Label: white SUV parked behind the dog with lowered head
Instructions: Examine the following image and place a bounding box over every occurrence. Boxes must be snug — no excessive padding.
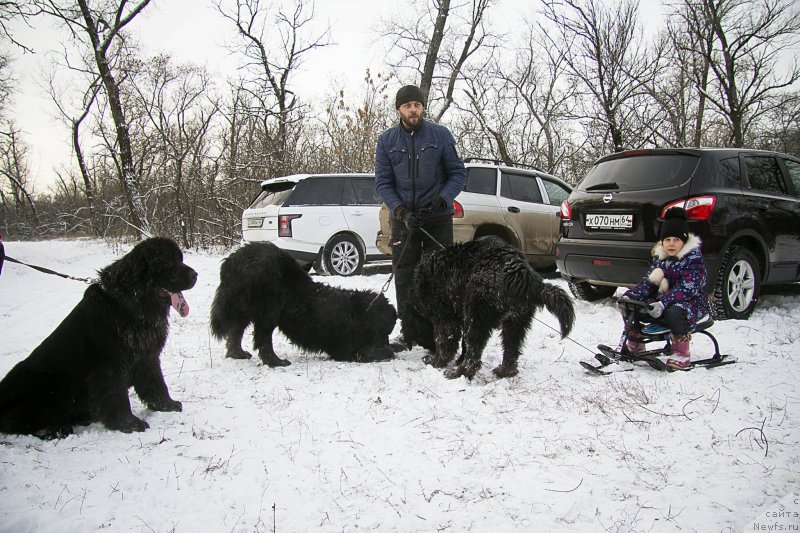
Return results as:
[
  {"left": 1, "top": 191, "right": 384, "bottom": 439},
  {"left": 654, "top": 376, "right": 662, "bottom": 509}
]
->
[{"left": 242, "top": 174, "right": 389, "bottom": 276}]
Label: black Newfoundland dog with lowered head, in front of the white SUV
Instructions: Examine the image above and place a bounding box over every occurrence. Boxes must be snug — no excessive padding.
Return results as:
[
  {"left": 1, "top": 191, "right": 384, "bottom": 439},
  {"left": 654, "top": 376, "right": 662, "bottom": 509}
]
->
[{"left": 211, "top": 242, "right": 397, "bottom": 367}]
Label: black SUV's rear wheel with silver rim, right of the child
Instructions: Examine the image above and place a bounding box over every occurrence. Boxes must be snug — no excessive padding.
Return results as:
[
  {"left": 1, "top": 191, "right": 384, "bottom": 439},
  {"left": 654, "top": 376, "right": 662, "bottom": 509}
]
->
[{"left": 711, "top": 246, "right": 761, "bottom": 320}]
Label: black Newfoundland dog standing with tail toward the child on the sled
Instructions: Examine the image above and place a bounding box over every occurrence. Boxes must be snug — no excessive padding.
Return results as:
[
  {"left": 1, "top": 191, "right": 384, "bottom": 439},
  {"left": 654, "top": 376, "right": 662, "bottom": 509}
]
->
[{"left": 414, "top": 238, "right": 575, "bottom": 379}]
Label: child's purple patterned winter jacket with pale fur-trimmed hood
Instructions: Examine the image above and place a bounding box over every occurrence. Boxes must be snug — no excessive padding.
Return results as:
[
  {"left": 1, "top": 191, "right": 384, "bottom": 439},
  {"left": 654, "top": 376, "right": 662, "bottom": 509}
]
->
[{"left": 623, "top": 233, "right": 710, "bottom": 329}]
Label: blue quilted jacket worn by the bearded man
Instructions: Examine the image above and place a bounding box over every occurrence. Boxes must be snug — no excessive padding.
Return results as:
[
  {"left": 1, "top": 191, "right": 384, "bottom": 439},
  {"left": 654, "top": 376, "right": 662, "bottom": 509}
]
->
[{"left": 375, "top": 120, "right": 467, "bottom": 217}]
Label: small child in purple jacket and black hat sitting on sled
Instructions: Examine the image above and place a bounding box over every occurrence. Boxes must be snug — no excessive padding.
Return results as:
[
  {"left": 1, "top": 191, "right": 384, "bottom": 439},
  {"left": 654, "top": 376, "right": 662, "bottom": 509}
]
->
[{"left": 623, "top": 207, "right": 709, "bottom": 370}]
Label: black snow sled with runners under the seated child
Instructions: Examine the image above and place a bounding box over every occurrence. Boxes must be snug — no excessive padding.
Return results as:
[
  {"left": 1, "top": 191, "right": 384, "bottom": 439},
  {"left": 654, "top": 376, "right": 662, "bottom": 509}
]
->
[{"left": 580, "top": 298, "right": 736, "bottom": 375}]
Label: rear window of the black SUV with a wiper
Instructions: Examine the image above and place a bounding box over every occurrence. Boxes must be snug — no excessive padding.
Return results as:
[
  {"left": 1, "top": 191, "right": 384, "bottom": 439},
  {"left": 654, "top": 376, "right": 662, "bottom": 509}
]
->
[{"left": 578, "top": 154, "right": 700, "bottom": 191}]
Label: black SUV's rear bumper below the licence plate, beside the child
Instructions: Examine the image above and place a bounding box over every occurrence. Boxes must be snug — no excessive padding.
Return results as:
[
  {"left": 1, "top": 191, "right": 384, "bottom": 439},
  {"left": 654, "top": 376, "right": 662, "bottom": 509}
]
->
[{"left": 556, "top": 238, "right": 653, "bottom": 286}]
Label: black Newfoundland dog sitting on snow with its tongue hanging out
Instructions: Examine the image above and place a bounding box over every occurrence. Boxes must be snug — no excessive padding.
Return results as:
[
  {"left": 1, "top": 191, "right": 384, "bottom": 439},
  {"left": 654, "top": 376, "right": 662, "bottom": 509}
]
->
[{"left": 0, "top": 237, "right": 197, "bottom": 438}]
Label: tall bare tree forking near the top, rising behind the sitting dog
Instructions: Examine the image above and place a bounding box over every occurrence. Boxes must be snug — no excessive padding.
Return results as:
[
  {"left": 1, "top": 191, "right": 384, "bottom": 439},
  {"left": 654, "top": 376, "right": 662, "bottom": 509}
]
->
[{"left": 34, "top": 0, "right": 151, "bottom": 237}]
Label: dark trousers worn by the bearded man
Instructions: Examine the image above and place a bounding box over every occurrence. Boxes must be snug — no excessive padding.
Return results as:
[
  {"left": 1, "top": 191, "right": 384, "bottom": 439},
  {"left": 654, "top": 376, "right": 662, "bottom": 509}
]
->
[{"left": 391, "top": 217, "right": 453, "bottom": 340}]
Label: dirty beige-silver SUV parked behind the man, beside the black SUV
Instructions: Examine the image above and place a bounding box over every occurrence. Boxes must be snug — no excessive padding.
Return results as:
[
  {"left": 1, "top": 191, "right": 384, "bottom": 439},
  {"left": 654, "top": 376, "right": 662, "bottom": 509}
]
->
[{"left": 375, "top": 158, "right": 572, "bottom": 270}]
